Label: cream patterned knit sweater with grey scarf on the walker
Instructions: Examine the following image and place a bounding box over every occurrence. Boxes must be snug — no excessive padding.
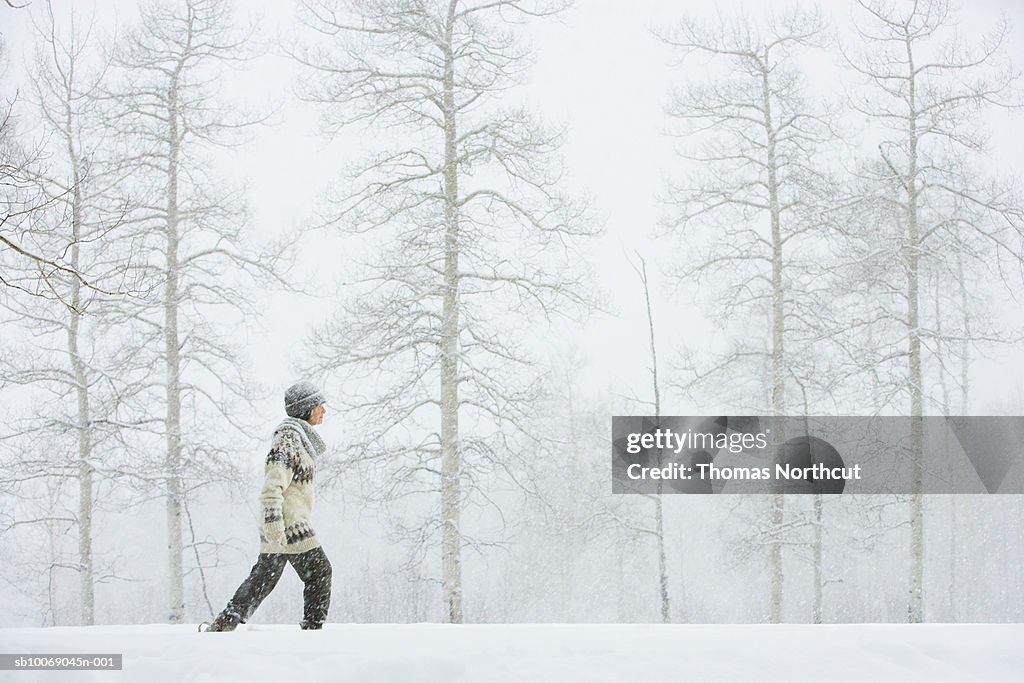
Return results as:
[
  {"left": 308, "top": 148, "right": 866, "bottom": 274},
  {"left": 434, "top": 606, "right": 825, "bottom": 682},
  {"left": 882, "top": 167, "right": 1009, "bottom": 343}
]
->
[{"left": 259, "top": 418, "right": 327, "bottom": 554}]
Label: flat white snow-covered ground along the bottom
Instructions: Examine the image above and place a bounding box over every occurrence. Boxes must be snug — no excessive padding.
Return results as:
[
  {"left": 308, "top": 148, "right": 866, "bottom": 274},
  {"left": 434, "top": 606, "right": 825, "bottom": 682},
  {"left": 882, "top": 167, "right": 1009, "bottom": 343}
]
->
[{"left": 0, "top": 624, "right": 1024, "bottom": 683}]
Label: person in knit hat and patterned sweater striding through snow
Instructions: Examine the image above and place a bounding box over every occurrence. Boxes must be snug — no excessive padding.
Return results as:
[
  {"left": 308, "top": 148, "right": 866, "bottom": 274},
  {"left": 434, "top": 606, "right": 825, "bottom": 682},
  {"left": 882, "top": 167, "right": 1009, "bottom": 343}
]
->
[{"left": 201, "top": 382, "right": 331, "bottom": 631}]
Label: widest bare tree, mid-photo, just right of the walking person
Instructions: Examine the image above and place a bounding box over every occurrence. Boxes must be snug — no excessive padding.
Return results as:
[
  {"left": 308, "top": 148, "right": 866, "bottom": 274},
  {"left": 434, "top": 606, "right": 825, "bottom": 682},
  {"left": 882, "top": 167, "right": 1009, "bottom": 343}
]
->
[{"left": 292, "top": 0, "right": 596, "bottom": 623}]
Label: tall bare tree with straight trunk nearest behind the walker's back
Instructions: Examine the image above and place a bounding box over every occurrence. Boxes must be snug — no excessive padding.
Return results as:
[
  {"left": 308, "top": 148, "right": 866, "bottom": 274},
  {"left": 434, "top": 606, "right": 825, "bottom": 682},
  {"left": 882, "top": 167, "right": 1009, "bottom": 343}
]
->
[{"left": 106, "top": 0, "right": 287, "bottom": 624}]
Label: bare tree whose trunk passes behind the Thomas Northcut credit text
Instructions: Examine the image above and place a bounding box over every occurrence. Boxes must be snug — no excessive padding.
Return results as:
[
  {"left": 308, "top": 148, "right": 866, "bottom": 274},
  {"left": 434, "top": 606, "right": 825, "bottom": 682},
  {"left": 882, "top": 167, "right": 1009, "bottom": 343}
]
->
[{"left": 662, "top": 3, "right": 836, "bottom": 623}]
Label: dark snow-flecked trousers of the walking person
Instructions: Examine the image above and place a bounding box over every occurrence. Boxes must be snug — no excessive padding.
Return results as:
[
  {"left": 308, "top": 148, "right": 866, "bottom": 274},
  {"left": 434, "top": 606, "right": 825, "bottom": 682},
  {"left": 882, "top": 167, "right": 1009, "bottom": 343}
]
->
[{"left": 224, "top": 548, "right": 331, "bottom": 625}]
